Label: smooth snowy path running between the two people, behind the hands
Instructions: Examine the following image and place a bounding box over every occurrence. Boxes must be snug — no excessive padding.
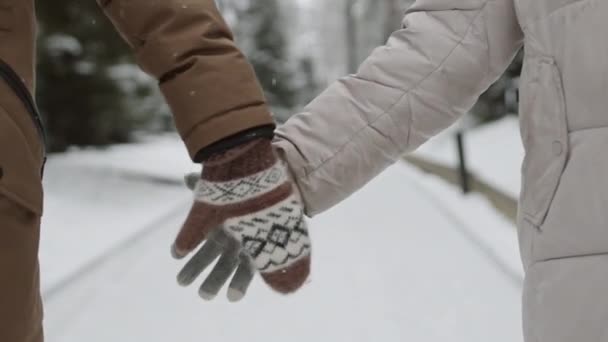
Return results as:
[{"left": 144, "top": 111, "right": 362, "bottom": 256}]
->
[{"left": 41, "top": 165, "right": 522, "bottom": 342}]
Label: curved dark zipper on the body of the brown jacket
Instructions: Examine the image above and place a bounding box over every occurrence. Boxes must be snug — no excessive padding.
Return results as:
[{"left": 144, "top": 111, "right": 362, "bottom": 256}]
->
[{"left": 0, "top": 59, "right": 47, "bottom": 177}]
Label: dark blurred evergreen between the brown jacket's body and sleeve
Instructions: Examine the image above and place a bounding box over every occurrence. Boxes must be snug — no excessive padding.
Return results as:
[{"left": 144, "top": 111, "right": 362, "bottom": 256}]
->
[{"left": 37, "top": 0, "right": 153, "bottom": 151}]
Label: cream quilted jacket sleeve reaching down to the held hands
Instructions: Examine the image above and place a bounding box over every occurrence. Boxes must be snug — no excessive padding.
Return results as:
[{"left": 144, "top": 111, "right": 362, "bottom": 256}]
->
[{"left": 275, "top": 0, "right": 523, "bottom": 216}]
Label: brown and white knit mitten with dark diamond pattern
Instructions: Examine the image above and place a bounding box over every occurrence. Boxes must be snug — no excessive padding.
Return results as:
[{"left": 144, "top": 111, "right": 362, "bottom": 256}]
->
[{"left": 173, "top": 139, "right": 311, "bottom": 293}]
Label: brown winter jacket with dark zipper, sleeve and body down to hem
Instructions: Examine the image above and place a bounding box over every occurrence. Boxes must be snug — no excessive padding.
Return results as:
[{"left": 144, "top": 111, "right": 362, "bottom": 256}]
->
[{"left": 0, "top": 0, "right": 273, "bottom": 214}]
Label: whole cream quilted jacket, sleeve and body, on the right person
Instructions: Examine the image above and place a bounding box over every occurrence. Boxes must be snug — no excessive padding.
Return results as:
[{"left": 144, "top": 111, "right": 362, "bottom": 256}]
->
[{"left": 275, "top": 0, "right": 608, "bottom": 342}]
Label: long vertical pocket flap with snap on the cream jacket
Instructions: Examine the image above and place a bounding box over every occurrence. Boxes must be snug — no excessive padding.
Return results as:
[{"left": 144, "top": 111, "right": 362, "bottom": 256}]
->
[{"left": 520, "top": 57, "right": 569, "bottom": 229}]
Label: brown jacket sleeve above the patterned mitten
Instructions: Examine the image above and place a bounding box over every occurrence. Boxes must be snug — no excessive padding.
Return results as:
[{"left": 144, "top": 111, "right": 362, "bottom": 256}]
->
[{"left": 97, "top": 0, "right": 273, "bottom": 158}]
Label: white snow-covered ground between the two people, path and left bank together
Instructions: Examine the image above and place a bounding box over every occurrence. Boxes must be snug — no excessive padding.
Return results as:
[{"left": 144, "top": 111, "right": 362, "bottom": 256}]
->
[{"left": 41, "top": 129, "right": 522, "bottom": 342}]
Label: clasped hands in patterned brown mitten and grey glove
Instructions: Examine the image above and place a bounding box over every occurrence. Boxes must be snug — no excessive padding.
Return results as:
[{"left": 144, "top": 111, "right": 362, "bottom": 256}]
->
[{"left": 172, "top": 139, "right": 311, "bottom": 301}]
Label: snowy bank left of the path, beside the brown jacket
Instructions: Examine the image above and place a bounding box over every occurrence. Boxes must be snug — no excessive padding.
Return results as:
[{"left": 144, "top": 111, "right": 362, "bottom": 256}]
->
[{"left": 40, "top": 135, "right": 194, "bottom": 293}]
